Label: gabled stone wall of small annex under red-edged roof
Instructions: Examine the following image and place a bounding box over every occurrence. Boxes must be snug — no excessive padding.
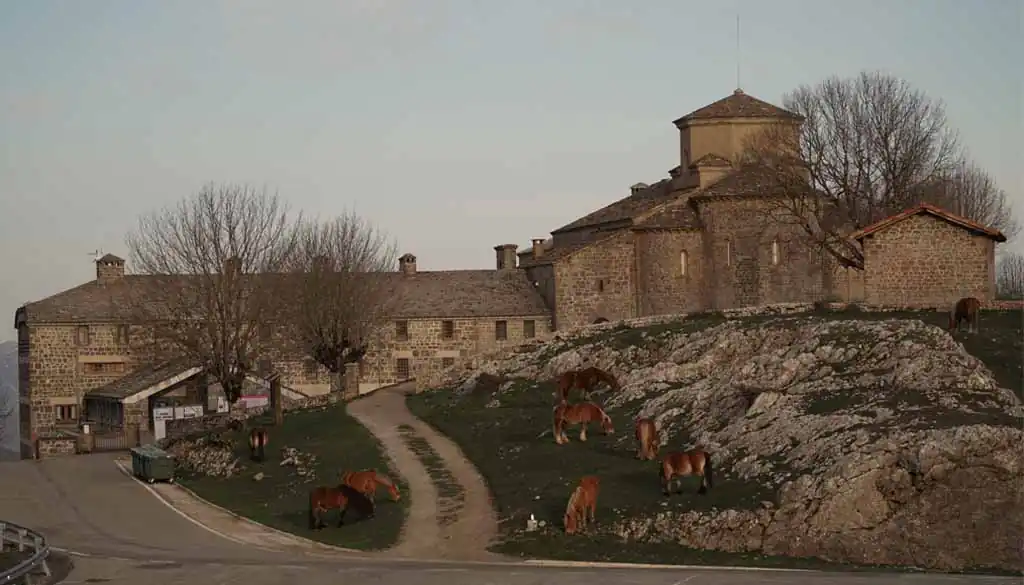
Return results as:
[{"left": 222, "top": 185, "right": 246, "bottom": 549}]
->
[{"left": 863, "top": 213, "right": 995, "bottom": 308}]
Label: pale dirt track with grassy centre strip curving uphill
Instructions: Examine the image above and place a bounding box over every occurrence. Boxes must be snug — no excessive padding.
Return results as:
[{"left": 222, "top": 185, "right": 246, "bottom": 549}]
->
[{"left": 348, "top": 386, "right": 501, "bottom": 560}]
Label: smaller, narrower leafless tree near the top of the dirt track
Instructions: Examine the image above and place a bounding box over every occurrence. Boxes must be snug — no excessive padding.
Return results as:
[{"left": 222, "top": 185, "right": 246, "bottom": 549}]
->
[{"left": 291, "top": 211, "right": 396, "bottom": 389}]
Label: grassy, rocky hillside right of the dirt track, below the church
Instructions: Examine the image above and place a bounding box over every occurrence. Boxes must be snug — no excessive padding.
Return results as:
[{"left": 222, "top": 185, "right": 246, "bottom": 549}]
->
[{"left": 410, "top": 305, "right": 1024, "bottom": 571}]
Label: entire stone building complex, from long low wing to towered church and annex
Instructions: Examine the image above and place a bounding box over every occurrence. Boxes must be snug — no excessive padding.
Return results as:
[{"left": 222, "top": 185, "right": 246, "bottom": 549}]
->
[{"left": 14, "top": 90, "right": 1006, "bottom": 461}]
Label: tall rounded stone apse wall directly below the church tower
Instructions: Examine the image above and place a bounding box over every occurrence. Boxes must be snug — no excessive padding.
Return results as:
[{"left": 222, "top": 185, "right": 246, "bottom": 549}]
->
[{"left": 698, "top": 198, "right": 827, "bottom": 309}]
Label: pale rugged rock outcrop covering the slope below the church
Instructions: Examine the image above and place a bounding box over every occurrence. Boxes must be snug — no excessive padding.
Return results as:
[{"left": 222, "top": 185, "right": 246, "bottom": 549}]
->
[{"left": 434, "top": 309, "right": 1024, "bottom": 570}]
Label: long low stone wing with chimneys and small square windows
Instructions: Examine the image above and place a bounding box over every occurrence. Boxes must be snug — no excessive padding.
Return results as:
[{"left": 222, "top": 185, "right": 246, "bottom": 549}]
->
[{"left": 14, "top": 249, "right": 552, "bottom": 456}]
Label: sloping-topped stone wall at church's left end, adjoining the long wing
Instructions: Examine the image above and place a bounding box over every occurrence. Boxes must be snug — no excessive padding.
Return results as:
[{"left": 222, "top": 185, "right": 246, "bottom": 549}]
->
[{"left": 555, "top": 231, "right": 636, "bottom": 330}]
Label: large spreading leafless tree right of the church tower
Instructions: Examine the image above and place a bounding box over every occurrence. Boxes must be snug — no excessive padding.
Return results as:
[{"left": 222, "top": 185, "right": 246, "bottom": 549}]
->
[{"left": 741, "top": 73, "right": 1015, "bottom": 268}]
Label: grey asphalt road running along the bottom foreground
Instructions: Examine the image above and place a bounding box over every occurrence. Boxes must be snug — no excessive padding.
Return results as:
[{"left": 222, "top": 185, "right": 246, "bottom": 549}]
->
[{"left": 0, "top": 455, "right": 1020, "bottom": 585}]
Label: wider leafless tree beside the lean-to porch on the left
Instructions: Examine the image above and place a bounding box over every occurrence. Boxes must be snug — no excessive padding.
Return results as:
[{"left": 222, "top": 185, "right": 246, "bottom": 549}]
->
[{"left": 128, "top": 184, "right": 297, "bottom": 403}]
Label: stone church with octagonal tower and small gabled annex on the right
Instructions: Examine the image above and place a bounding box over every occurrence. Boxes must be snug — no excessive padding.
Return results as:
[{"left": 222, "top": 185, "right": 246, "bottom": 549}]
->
[{"left": 517, "top": 89, "right": 1006, "bottom": 329}]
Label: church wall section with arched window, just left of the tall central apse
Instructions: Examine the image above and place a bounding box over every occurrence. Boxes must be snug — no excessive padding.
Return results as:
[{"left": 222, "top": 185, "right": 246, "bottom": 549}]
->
[{"left": 634, "top": 229, "right": 708, "bottom": 317}]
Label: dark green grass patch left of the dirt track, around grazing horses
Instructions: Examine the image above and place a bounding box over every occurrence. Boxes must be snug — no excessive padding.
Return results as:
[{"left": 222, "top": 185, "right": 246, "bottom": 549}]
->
[{"left": 178, "top": 404, "right": 409, "bottom": 550}]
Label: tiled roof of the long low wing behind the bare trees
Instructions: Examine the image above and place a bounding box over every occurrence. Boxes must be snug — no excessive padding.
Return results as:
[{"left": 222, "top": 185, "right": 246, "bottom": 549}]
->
[{"left": 18, "top": 270, "right": 550, "bottom": 323}]
